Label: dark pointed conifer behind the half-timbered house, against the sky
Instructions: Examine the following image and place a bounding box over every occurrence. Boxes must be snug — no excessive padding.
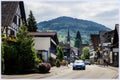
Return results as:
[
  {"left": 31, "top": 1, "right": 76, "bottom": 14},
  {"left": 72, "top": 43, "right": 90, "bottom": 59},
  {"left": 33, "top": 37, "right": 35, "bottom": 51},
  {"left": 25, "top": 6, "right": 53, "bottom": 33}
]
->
[{"left": 27, "top": 10, "right": 37, "bottom": 32}]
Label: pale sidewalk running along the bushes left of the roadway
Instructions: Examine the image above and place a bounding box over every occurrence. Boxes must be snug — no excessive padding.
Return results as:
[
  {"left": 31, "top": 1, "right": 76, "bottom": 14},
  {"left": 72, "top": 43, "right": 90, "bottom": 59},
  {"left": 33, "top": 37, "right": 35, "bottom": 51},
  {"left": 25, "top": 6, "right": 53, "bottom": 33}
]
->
[{"left": 1, "top": 66, "right": 69, "bottom": 79}]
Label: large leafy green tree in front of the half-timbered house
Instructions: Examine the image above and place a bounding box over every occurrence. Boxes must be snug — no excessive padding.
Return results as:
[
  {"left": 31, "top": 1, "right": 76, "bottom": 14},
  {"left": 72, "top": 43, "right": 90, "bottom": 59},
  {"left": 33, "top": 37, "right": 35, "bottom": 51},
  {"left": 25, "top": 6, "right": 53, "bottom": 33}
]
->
[{"left": 17, "top": 22, "right": 38, "bottom": 72}]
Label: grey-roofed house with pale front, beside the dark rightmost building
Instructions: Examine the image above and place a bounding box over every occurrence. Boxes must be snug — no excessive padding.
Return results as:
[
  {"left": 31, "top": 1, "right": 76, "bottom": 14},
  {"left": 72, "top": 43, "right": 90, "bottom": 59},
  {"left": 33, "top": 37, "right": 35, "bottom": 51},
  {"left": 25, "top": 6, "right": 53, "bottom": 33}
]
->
[{"left": 99, "top": 30, "right": 114, "bottom": 64}]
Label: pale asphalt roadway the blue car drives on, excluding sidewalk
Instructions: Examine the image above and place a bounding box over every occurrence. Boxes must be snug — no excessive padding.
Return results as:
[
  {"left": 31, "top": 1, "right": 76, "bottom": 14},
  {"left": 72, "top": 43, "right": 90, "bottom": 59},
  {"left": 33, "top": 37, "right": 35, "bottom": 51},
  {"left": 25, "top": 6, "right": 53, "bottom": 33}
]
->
[{"left": 45, "top": 65, "right": 118, "bottom": 79}]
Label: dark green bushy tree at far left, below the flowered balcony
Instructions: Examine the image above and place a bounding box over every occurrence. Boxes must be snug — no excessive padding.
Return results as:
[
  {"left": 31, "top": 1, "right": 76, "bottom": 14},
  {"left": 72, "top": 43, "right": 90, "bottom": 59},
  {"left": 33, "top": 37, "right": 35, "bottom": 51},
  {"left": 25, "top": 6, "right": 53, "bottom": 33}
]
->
[{"left": 4, "top": 43, "right": 19, "bottom": 74}]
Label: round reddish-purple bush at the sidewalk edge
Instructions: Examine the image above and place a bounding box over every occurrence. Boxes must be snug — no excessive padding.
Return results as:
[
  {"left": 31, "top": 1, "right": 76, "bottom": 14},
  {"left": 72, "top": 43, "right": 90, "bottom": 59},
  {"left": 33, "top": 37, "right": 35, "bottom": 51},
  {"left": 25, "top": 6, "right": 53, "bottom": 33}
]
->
[{"left": 39, "top": 63, "right": 51, "bottom": 73}]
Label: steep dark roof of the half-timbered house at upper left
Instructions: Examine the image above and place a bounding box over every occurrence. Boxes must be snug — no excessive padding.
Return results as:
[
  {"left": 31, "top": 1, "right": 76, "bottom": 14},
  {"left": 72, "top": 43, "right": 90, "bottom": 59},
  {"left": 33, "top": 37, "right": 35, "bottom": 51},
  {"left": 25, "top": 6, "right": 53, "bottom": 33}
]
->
[{"left": 1, "top": 1, "right": 26, "bottom": 26}]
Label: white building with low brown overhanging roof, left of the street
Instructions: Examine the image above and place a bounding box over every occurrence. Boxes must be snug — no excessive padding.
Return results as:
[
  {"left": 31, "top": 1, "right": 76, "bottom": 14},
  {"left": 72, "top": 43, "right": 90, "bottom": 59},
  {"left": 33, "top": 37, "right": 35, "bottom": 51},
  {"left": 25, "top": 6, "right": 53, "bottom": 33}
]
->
[{"left": 29, "top": 32, "right": 59, "bottom": 62}]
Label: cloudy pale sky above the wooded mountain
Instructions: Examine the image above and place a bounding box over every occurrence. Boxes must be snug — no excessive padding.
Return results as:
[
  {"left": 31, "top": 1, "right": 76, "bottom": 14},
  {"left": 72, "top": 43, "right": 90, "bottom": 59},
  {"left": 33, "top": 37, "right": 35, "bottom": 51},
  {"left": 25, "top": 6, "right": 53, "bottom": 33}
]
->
[{"left": 24, "top": 0, "right": 120, "bottom": 30}]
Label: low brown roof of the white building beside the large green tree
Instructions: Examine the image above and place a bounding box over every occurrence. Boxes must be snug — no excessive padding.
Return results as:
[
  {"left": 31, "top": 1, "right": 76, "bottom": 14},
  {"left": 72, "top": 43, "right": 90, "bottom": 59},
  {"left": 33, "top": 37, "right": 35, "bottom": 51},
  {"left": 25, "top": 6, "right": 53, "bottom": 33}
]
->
[{"left": 29, "top": 32, "right": 59, "bottom": 44}]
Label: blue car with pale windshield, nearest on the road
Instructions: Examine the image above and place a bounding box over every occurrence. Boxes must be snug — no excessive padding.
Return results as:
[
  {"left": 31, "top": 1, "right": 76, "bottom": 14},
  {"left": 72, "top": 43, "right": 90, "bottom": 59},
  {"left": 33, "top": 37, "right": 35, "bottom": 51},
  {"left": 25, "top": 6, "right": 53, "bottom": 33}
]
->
[{"left": 73, "top": 60, "right": 86, "bottom": 70}]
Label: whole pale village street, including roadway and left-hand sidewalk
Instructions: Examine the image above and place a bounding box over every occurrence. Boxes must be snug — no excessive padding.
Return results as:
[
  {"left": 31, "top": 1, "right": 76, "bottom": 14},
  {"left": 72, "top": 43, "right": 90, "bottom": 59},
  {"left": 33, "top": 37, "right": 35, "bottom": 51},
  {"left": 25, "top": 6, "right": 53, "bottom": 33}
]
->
[{"left": 2, "top": 65, "right": 119, "bottom": 79}]
